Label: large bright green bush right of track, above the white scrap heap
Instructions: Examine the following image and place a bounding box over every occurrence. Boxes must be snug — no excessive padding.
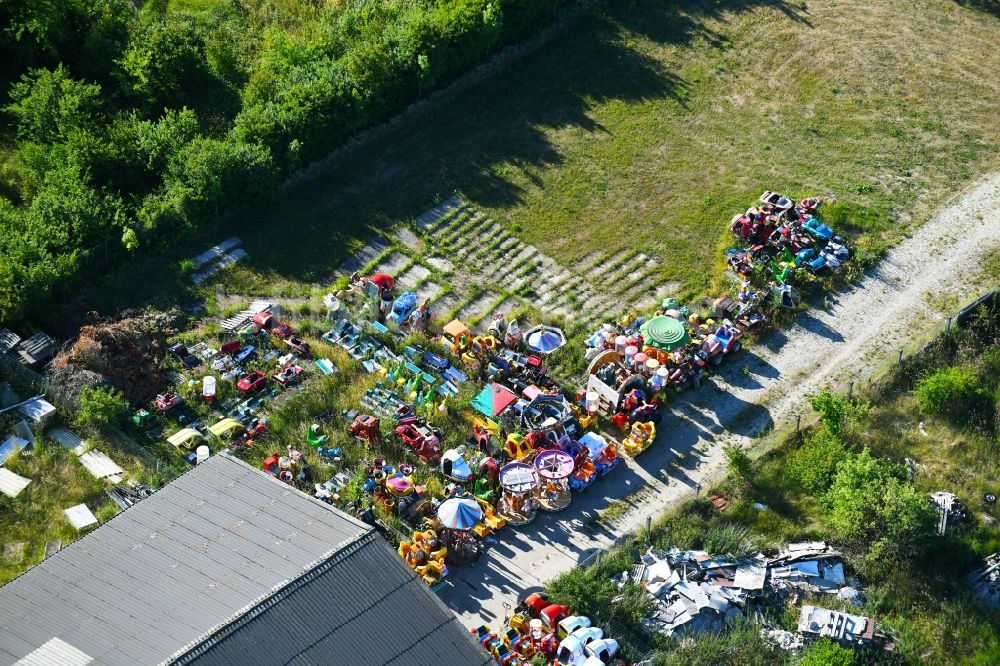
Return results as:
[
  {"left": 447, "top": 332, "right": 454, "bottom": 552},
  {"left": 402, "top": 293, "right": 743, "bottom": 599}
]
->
[{"left": 825, "top": 449, "right": 937, "bottom": 574}]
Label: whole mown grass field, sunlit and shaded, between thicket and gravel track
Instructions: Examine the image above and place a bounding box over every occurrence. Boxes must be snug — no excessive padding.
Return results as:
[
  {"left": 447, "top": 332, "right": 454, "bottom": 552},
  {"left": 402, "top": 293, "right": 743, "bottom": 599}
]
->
[{"left": 60, "top": 0, "right": 1000, "bottom": 326}]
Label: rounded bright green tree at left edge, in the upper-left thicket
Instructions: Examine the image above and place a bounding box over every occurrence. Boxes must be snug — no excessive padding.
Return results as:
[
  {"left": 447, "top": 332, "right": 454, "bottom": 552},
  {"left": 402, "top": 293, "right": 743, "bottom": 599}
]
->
[{"left": 4, "top": 65, "right": 101, "bottom": 143}]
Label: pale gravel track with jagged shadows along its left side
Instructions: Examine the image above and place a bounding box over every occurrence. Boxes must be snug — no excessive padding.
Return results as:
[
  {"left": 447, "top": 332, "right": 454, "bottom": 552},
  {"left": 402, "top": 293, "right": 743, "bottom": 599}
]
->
[{"left": 441, "top": 173, "right": 1000, "bottom": 625}]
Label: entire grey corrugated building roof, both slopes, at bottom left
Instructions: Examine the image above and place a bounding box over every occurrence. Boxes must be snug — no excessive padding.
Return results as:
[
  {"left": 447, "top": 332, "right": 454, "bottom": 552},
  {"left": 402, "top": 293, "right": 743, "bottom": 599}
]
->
[{"left": 0, "top": 455, "right": 488, "bottom": 666}]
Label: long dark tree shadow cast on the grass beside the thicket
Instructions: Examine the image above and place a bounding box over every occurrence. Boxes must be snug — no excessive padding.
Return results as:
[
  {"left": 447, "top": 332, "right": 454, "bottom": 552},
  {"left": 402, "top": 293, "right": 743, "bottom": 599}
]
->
[{"left": 64, "top": 0, "right": 802, "bottom": 330}]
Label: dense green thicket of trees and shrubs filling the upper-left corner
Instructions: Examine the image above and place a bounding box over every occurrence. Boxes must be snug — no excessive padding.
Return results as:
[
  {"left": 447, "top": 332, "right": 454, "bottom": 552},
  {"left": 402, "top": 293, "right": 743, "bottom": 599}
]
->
[{"left": 0, "top": 0, "right": 574, "bottom": 320}]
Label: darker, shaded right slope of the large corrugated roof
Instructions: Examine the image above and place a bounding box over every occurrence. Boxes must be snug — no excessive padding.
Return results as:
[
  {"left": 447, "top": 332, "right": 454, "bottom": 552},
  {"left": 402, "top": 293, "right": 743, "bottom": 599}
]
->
[{"left": 174, "top": 533, "right": 492, "bottom": 666}]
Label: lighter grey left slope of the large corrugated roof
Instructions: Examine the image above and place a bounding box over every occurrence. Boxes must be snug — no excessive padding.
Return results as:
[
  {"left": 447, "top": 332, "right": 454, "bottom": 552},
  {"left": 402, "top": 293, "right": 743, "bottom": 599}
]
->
[{"left": 0, "top": 455, "right": 372, "bottom": 666}]
